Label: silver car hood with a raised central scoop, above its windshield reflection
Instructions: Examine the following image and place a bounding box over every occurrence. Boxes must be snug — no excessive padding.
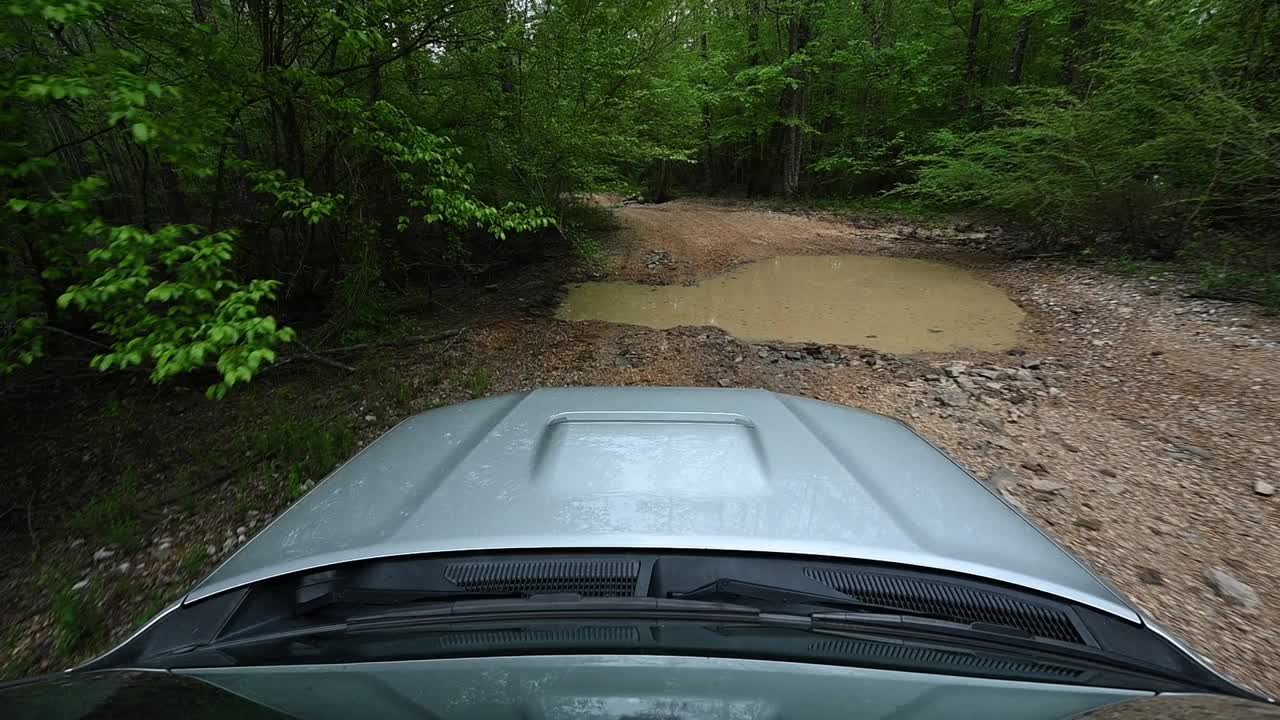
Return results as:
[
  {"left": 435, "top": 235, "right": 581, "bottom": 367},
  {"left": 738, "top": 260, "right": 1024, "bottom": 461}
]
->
[{"left": 187, "top": 388, "right": 1139, "bottom": 621}]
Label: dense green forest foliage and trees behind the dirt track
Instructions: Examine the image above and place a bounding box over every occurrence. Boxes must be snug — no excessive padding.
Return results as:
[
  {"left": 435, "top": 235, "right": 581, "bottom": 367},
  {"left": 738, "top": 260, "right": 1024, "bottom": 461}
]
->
[{"left": 0, "top": 0, "right": 1280, "bottom": 395}]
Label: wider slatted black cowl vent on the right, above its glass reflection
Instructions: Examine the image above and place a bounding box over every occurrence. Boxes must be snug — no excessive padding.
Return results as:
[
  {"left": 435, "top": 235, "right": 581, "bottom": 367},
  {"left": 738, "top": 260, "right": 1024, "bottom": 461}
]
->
[{"left": 804, "top": 568, "right": 1084, "bottom": 644}]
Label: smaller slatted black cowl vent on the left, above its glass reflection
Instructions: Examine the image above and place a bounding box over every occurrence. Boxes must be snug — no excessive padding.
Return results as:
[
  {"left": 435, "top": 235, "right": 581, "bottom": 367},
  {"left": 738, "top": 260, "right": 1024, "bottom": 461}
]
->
[{"left": 444, "top": 560, "right": 640, "bottom": 597}]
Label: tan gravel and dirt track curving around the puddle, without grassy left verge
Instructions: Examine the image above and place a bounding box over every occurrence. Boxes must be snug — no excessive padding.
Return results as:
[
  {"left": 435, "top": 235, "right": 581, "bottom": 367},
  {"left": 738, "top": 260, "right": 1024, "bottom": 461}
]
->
[{"left": 476, "top": 201, "right": 1280, "bottom": 694}]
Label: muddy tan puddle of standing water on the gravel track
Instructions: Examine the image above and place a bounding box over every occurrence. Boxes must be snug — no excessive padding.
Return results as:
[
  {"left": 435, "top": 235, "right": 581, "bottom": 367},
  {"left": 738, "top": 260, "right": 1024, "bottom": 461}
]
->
[{"left": 557, "top": 255, "right": 1023, "bottom": 352}]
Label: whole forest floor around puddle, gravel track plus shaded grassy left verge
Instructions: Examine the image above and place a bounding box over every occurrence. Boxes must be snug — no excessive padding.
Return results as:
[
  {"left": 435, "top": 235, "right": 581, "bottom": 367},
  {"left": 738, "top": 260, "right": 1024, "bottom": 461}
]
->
[{"left": 0, "top": 196, "right": 1280, "bottom": 694}]
